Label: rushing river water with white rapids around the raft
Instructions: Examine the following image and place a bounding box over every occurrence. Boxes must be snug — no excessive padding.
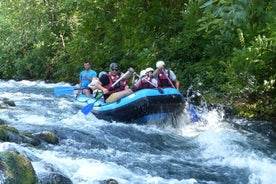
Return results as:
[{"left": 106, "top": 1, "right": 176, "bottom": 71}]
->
[{"left": 0, "top": 80, "right": 276, "bottom": 184}]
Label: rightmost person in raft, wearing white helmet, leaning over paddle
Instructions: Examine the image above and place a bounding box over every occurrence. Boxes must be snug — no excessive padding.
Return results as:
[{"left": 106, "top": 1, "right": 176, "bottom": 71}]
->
[{"left": 152, "top": 61, "right": 180, "bottom": 90}]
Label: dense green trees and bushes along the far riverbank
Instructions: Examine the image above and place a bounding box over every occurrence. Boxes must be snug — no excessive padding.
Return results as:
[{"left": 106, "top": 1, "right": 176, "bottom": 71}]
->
[{"left": 0, "top": 0, "right": 276, "bottom": 121}]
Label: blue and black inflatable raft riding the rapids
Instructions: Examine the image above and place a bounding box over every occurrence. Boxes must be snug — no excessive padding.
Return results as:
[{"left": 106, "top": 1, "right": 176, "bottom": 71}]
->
[{"left": 74, "top": 88, "right": 185, "bottom": 123}]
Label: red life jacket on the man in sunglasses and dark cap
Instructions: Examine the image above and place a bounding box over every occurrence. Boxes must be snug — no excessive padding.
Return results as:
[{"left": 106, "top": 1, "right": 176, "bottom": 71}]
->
[{"left": 103, "top": 74, "right": 127, "bottom": 94}]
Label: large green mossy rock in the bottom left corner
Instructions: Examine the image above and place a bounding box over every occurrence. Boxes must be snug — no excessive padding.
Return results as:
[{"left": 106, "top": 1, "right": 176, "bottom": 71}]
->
[{"left": 0, "top": 151, "right": 38, "bottom": 184}]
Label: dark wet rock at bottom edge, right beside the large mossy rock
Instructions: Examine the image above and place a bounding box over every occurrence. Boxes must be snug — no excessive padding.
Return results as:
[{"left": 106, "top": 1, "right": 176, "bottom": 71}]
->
[{"left": 39, "top": 173, "right": 73, "bottom": 184}]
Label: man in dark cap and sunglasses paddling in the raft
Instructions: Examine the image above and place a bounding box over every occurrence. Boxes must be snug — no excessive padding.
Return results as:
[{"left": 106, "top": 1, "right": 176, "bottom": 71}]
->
[{"left": 95, "top": 63, "right": 134, "bottom": 102}]
